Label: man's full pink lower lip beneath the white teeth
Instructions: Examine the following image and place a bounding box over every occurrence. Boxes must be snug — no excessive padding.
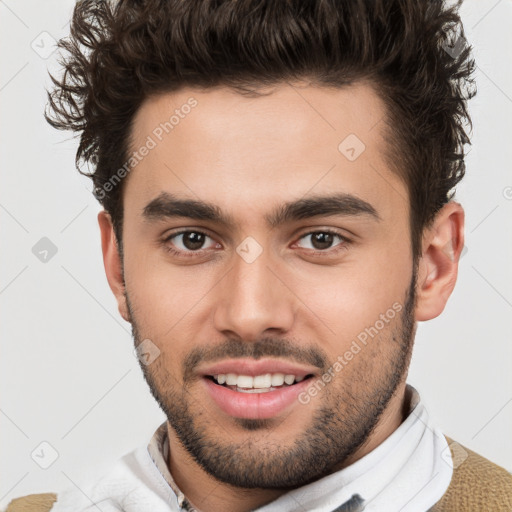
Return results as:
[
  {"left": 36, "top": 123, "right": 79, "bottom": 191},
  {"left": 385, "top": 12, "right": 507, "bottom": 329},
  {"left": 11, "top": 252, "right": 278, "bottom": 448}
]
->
[{"left": 203, "top": 378, "right": 310, "bottom": 419}]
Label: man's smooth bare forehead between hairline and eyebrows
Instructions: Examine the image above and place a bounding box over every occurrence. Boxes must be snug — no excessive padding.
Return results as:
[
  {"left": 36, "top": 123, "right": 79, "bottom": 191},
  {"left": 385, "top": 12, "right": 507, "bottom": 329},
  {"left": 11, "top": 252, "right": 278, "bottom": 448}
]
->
[{"left": 123, "top": 84, "right": 407, "bottom": 224}]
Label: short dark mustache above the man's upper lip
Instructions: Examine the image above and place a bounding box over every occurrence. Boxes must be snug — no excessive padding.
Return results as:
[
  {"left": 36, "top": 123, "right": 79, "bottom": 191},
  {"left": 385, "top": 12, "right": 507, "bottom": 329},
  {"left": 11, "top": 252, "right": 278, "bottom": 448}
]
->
[{"left": 183, "top": 337, "right": 327, "bottom": 382}]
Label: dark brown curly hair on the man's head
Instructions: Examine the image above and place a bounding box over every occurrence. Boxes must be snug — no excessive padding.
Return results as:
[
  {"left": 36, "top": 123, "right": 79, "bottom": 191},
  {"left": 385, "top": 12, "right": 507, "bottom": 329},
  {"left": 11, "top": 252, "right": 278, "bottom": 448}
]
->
[{"left": 45, "top": 0, "right": 476, "bottom": 256}]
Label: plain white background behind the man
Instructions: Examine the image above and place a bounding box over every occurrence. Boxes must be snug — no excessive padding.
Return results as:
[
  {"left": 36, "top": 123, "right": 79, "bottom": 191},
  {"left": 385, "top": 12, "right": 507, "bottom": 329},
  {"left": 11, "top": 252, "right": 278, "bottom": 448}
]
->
[{"left": 0, "top": 0, "right": 512, "bottom": 506}]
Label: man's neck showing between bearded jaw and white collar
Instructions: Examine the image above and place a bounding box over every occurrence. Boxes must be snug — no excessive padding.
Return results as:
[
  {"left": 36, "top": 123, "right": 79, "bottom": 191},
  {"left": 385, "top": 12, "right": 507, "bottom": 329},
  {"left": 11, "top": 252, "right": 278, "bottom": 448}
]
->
[{"left": 167, "top": 382, "right": 410, "bottom": 512}]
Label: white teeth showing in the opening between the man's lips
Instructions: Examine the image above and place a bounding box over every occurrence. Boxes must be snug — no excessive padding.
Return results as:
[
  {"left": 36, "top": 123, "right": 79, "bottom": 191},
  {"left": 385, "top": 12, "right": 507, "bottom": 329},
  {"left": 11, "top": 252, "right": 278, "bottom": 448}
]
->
[{"left": 206, "top": 373, "right": 313, "bottom": 393}]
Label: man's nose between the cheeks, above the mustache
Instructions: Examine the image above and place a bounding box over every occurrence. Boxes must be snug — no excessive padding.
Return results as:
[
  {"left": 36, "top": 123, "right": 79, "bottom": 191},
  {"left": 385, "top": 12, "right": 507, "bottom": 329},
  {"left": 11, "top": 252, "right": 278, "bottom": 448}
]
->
[{"left": 214, "top": 245, "right": 296, "bottom": 341}]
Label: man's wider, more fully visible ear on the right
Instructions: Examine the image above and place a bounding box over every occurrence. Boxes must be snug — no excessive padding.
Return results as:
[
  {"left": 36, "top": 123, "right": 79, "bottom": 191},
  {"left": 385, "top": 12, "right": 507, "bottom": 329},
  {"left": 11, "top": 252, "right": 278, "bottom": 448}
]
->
[{"left": 415, "top": 201, "right": 464, "bottom": 322}]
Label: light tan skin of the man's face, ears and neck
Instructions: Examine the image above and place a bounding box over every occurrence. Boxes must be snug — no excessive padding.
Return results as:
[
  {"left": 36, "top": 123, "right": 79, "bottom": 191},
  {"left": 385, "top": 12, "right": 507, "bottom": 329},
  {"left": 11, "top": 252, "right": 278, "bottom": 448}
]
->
[{"left": 98, "top": 83, "right": 464, "bottom": 512}]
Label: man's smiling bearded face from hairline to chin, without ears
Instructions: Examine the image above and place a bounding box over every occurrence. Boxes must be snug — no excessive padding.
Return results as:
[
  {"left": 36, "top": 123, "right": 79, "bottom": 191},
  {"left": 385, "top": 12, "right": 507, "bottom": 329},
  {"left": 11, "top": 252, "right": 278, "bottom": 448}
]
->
[{"left": 123, "top": 84, "right": 414, "bottom": 488}]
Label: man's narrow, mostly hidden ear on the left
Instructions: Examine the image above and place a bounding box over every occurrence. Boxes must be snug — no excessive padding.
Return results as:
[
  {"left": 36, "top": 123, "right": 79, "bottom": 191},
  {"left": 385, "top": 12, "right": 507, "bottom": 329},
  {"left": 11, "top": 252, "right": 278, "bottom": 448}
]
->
[{"left": 98, "top": 210, "right": 131, "bottom": 322}]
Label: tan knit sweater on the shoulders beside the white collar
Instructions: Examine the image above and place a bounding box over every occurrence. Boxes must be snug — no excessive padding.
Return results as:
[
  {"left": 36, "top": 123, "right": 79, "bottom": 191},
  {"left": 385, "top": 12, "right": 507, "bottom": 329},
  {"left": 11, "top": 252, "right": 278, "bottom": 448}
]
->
[{"left": 5, "top": 437, "right": 512, "bottom": 512}]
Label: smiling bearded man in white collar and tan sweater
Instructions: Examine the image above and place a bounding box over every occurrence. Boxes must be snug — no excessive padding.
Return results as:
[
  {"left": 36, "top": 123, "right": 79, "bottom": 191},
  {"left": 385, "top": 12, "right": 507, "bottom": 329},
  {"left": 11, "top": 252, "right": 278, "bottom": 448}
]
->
[{"left": 8, "top": 0, "right": 512, "bottom": 512}]
